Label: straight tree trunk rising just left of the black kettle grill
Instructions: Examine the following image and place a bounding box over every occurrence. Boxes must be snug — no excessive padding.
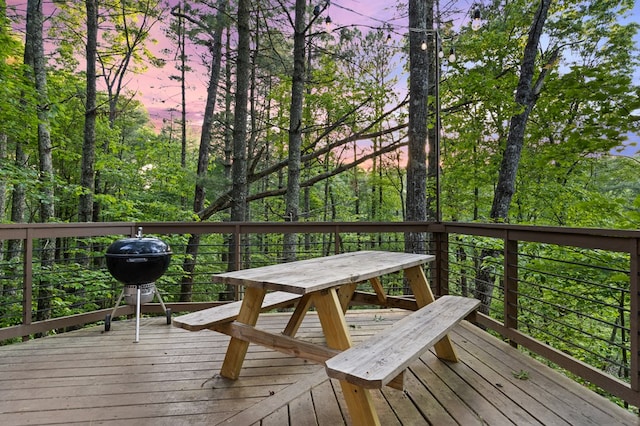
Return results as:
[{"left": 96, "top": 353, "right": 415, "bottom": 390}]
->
[{"left": 78, "top": 0, "right": 98, "bottom": 222}]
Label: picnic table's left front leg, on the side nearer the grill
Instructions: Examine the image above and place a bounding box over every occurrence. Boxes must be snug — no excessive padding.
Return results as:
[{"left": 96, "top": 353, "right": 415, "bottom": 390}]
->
[{"left": 220, "top": 287, "right": 267, "bottom": 380}]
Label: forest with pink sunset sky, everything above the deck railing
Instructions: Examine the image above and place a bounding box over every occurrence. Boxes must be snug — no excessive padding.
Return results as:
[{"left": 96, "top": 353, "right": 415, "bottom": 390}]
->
[{"left": 0, "top": 0, "right": 640, "bottom": 233}]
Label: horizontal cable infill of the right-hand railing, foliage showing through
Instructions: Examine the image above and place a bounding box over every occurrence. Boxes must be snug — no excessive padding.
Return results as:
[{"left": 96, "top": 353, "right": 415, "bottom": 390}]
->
[{"left": 446, "top": 233, "right": 631, "bottom": 402}]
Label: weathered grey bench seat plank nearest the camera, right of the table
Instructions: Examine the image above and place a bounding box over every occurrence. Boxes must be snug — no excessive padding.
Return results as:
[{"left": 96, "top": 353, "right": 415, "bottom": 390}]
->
[{"left": 325, "top": 296, "right": 480, "bottom": 389}]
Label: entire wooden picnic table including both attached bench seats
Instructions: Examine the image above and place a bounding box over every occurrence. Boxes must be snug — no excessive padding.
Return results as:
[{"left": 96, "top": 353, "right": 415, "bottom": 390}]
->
[{"left": 173, "top": 251, "right": 479, "bottom": 426}]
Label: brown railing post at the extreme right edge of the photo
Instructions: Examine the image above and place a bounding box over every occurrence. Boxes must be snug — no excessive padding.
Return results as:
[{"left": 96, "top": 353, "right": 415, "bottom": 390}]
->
[{"left": 629, "top": 238, "right": 640, "bottom": 392}]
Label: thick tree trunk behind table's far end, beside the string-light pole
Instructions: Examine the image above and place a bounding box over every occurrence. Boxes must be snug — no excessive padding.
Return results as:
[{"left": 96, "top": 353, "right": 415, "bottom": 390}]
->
[{"left": 405, "top": 0, "right": 433, "bottom": 253}]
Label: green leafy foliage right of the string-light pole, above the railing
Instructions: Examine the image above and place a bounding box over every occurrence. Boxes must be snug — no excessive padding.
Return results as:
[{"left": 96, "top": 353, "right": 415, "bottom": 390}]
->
[{"left": 441, "top": 1, "right": 640, "bottom": 228}]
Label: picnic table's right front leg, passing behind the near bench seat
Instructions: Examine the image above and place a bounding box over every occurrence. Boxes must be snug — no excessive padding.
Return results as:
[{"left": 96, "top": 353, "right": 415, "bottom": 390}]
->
[{"left": 313, "top": 289, "right": 380, "bottom": 426}]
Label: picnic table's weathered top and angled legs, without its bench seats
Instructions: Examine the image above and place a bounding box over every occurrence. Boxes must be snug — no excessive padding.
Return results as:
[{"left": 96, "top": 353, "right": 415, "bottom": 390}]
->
[{"left": 208, "top": 251, "right": 456, "bottom": 425}]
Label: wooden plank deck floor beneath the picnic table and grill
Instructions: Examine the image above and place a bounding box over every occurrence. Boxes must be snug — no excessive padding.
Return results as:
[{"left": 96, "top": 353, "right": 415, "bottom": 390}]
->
[{"left": 0, "top": 310, "right": 640, "bottom": 426}]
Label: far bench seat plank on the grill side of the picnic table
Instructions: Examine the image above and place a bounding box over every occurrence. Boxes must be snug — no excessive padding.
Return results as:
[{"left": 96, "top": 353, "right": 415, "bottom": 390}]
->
[{"left": 173, "top": 291, "right": 301, "bottom": 331}]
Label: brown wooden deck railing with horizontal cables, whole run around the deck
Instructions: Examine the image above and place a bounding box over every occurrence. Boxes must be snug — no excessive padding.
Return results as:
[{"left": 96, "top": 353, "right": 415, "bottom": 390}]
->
[{"left": 0, "top": 222, "right": 640, "bottom": 407}]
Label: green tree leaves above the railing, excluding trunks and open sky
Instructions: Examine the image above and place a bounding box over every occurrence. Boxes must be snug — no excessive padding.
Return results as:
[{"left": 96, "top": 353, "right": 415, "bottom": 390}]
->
[{"left": 0, "top": 0, "right": 640, "bottom": 228}]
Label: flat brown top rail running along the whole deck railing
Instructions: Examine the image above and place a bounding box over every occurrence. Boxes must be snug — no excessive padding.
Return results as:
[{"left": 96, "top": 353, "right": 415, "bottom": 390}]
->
[{"left": 0, "top": 222, "right": 640, "bottom": 251}]
